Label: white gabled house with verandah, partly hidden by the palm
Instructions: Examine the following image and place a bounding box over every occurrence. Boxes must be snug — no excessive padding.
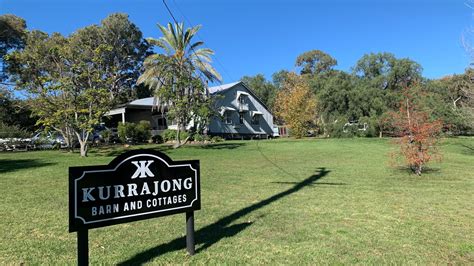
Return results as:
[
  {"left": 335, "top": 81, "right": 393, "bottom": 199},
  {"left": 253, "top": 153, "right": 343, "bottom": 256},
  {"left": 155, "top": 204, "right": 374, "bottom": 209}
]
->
[{"left": 106, "top": 81, "right": 274, "bottom": 138}]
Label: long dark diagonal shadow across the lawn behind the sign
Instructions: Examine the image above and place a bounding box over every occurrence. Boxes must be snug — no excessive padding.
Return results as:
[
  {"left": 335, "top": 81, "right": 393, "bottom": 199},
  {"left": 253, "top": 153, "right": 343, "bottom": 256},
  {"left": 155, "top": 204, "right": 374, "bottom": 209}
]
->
[{"left": 119, "top": 167, "right": 330, "bottom": 265}]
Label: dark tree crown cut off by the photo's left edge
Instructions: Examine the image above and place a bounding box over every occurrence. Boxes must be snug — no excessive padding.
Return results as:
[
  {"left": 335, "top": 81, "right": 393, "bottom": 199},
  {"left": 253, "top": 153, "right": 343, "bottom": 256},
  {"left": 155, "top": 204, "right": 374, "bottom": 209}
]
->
[{"left": 0, "top": 14, "right": 26, "bottom": 82}]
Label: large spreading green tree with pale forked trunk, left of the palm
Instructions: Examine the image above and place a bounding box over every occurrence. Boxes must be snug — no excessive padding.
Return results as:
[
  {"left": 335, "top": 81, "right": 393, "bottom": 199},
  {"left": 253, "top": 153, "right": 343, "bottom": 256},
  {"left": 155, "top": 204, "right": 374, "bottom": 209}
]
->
[{"left": 7, "top": 14, "right": 148, "bottom": 156}]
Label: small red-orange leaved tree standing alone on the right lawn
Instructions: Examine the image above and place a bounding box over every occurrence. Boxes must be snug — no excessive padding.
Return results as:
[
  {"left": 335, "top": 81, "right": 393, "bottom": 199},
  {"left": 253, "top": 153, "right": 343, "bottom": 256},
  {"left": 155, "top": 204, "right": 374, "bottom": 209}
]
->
[{"left": 392, "top": 87, "right": 442, "bottom": 175}]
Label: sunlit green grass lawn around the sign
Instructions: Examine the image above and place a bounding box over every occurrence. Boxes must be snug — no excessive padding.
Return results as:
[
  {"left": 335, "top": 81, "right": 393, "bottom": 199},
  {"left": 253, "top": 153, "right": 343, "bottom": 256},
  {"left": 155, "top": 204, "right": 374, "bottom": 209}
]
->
[{"left": 0, "top": 138, "right": 474, "bottom": 264}]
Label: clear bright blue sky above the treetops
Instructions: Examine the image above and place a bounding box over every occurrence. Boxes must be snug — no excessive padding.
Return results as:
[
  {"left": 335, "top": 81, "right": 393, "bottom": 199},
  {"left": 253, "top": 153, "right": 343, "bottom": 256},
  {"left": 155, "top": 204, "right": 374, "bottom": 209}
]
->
[{"left": 0, "top": 0, "right": 473, "bottom": 82}]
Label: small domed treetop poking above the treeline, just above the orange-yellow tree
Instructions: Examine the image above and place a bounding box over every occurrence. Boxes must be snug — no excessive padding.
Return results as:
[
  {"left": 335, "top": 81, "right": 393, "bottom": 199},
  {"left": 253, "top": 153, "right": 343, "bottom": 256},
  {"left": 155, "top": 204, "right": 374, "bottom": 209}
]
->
[{"left": 296, "top": 50, "right": 337, "bottom": 75}]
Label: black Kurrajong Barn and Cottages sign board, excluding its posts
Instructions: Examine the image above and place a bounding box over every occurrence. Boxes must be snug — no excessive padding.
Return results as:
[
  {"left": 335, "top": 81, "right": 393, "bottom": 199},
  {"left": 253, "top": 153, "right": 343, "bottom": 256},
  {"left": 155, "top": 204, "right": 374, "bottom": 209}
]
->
[{"left": 69, "top": 150, "right": 201, "bottom": 232}]
